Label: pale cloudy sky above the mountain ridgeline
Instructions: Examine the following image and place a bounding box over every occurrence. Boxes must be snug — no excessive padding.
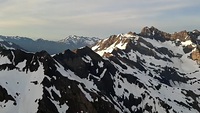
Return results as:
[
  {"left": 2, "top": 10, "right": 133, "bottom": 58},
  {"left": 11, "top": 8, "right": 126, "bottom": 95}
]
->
[{"left": 0, "top": 0, "right": 200, "bottom": 40}]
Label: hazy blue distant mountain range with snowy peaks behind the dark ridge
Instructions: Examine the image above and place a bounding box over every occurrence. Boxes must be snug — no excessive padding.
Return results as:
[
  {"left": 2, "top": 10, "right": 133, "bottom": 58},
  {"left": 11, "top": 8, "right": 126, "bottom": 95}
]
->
[{"left": 0, "top": 36, "right": 99, "bottom": 54}]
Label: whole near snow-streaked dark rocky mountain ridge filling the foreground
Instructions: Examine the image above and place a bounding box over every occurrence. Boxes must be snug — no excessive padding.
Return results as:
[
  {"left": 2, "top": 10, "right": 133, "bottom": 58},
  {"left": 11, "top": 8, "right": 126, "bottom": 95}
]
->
[{"left": 0, "top": 27, "right": 200, "bottom": 113}]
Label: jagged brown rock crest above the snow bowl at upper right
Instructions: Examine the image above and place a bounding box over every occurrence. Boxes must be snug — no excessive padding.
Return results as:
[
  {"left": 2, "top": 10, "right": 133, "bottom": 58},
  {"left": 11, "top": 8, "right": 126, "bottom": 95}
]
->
[{"left": 139, "top": 27, "right": 200, "bottom": 62}]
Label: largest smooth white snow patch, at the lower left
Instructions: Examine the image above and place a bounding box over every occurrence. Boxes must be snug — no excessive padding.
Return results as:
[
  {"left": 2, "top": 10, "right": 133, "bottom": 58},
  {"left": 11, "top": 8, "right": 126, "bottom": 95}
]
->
[{"left": 0, "top": 64, "right": 45, "bottom": 113}]
